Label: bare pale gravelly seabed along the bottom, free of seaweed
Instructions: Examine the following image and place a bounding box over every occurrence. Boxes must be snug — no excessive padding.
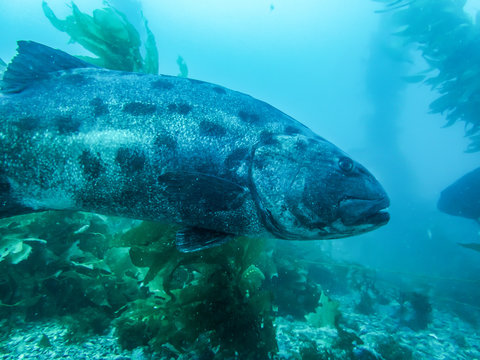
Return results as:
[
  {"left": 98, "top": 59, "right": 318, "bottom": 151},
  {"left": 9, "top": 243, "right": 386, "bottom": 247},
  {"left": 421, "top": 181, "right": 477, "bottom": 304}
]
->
[{"left": 0, "top": 295, "right": 480, "bottom": 360}]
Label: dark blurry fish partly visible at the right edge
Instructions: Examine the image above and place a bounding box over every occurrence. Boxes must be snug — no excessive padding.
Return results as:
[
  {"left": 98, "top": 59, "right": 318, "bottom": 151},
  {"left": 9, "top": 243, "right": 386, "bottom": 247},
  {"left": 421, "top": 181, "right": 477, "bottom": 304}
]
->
[{"left": 437, "top": 167, "right": 480, "bottom": 222}]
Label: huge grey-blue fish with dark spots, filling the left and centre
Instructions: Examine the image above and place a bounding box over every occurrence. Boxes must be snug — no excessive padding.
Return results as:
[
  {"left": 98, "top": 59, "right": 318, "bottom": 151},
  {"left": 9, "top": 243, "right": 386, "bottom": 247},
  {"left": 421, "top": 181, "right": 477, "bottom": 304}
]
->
[{"left": 0, "top": 41, "right": 390, "bottom": 252}]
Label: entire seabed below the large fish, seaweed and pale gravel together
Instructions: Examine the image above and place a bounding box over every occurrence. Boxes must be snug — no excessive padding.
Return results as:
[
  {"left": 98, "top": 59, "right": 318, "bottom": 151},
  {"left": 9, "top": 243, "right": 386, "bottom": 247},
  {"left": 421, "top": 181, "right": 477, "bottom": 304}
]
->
[{"left": 0, "top": 213, "right": 480, "bottom": 360}]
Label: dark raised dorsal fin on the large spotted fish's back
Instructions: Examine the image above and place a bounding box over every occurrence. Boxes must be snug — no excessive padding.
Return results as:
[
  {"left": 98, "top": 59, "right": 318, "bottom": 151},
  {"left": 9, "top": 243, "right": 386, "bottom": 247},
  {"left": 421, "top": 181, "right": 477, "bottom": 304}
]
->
[{"left": 1, "top": 41, "right": 95, "bottom": 93}]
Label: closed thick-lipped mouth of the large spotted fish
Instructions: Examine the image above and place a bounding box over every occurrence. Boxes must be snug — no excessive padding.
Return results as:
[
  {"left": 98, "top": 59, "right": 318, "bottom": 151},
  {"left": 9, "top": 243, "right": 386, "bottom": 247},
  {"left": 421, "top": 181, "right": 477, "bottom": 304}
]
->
[{"left": 339, "top": 197, "right": 390, "bottom": 226}]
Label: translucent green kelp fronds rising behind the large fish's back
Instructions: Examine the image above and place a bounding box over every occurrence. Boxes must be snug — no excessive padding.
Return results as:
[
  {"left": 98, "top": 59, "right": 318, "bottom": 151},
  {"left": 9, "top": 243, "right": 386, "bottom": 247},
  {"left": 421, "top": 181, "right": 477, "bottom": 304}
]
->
[{"left": 42, "top": 1, "right": 158, "bottom": 74}]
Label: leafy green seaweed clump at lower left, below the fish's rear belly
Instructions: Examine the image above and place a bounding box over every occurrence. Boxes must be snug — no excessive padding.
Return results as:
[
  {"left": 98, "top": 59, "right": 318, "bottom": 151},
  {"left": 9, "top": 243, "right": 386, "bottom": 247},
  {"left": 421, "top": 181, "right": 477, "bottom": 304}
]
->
[{"left": 0, "top": 212, "right": 141, "bottom": 319}]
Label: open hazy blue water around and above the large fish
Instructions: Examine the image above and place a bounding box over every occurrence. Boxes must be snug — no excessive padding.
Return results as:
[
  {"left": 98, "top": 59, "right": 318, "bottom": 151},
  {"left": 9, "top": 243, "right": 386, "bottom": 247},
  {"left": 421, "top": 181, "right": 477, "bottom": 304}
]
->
[{"left": 0, "top": 0, "right": 480, "bottom": 358}]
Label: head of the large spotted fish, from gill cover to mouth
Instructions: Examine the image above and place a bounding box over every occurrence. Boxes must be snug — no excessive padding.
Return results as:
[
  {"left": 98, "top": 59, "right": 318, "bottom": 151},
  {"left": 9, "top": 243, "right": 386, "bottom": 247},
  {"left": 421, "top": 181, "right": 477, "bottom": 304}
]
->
[{"left": 250, "top": 134, "right": 390, "bottom": 240}]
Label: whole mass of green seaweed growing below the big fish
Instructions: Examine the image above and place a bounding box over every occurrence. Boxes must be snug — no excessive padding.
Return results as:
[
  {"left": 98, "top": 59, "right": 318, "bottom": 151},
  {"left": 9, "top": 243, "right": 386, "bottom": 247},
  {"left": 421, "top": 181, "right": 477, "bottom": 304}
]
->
[{"left": 0, "top": 212, "right": 408, "bottom": 359}]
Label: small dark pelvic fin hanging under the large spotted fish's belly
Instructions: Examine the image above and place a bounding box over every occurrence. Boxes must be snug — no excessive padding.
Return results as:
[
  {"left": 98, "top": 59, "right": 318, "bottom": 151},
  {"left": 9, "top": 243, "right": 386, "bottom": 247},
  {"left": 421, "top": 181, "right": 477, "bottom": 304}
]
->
[{"left": 176, "top": 227, "right": 235, "bottom": 253}]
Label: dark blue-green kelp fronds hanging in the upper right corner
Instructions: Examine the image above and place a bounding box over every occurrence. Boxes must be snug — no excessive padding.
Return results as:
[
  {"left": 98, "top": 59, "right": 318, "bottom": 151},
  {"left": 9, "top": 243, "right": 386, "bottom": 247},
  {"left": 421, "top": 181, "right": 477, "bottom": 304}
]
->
[{"left": 375, "top": 0, "right": 480, "bottom": 152}]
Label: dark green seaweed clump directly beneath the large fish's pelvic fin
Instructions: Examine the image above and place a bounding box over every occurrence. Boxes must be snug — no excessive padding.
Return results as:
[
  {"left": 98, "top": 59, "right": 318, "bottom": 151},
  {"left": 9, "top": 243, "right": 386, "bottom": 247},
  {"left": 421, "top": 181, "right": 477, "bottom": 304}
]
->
[{"left": 115, "top": 222, "right": 276, "bottom": 359}]
